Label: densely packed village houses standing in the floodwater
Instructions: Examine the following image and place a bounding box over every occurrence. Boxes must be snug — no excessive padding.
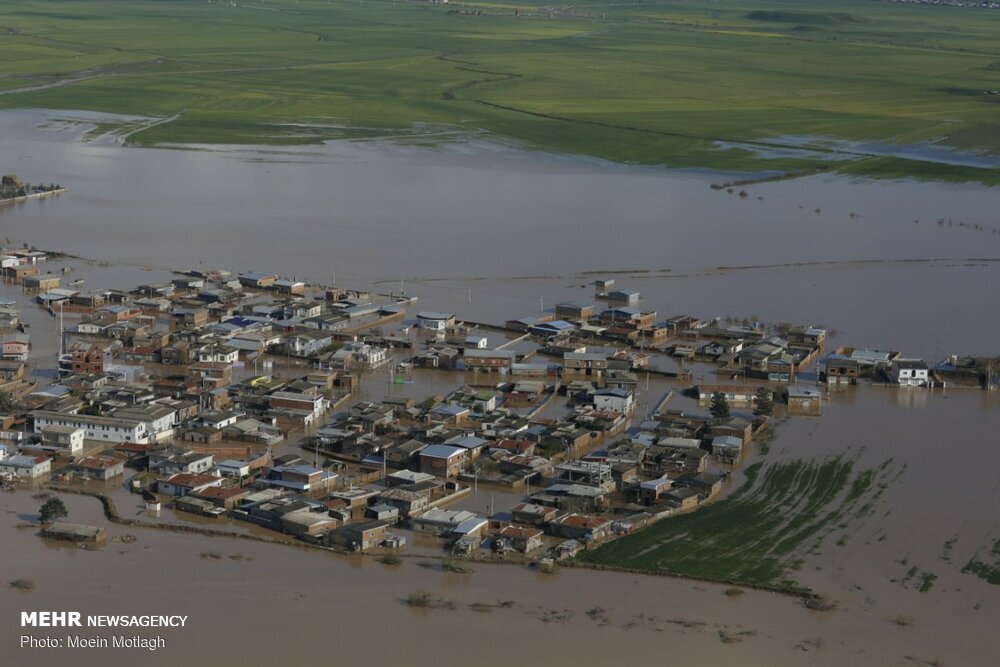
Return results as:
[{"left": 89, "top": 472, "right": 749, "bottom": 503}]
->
[{"left": 0, "top": 260, "right": 993, "bottom": 557}]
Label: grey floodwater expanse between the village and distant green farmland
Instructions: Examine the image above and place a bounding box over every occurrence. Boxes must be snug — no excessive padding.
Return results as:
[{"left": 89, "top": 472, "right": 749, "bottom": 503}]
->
[{"left": 0, "top": 111, "right": 1000, "bottom": 357}]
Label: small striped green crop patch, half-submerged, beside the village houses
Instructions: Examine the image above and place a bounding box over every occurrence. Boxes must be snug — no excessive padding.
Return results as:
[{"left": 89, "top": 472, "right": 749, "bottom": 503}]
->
[{"left": 579, "top": 458, "right": 889, "bottom": 592}]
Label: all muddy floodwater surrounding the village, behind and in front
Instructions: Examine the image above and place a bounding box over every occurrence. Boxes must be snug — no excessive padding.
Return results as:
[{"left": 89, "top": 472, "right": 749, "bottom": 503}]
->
[{"left": 0, "top": 111, "right": 1000, "bottom": 666}]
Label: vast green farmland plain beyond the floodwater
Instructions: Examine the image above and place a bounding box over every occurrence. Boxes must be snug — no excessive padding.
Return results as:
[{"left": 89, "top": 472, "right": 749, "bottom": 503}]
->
[{"left": 0, "top": 0, "right": 1000, "bottom": 183}]
